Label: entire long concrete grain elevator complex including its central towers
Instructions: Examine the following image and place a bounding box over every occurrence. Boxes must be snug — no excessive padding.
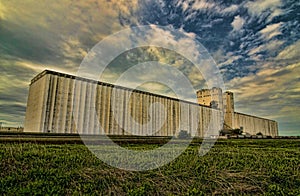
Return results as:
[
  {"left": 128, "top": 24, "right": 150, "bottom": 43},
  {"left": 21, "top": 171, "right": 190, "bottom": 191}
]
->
[{"left": 24, "top": 70, "right": 278, "bottom": 137}]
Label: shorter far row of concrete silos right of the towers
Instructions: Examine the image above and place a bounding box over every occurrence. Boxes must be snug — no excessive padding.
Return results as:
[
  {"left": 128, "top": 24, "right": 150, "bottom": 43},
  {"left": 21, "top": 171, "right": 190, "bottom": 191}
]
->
[{"left": 233, "top": 112, "right": 278, "bottom": 137}]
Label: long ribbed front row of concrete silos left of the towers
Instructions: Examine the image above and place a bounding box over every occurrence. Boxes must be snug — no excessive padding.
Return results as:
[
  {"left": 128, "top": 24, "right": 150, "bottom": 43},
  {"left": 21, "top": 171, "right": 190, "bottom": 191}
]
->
[{"left": 27, "top": 72, "right": 222, "bottom": 137}]
